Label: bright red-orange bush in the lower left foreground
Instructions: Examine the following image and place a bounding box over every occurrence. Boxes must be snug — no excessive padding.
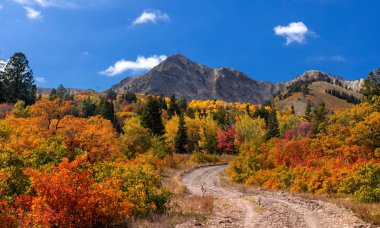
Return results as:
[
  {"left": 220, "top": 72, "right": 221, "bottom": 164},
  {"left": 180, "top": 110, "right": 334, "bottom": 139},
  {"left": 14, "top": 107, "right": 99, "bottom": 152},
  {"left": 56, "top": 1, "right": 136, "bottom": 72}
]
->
[{"left": 23, "top": 156, "right": 133, "bottom": 227}]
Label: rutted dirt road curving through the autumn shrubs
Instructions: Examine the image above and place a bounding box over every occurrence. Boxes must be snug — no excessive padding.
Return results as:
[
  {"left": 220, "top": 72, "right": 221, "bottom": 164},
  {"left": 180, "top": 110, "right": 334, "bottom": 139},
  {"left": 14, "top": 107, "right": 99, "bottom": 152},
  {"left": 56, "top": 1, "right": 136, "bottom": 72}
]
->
[{"left": 177, "top": 165, "right": 370, "bottom": 228}]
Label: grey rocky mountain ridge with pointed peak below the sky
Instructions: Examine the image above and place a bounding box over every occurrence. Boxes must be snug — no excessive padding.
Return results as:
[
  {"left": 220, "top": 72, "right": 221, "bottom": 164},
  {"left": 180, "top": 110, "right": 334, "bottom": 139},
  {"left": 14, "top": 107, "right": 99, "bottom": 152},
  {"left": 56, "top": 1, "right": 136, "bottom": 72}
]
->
[{"left": 111, "top": 54, "right": 362, "bottom": 104}]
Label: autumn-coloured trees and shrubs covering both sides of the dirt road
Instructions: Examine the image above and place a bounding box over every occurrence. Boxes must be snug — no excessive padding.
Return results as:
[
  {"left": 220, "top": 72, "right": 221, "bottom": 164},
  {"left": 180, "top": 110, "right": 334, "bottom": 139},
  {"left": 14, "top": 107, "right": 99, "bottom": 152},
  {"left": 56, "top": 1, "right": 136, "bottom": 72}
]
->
[{"left": 0, "top": 53, "right": 380, "bottom": 227}]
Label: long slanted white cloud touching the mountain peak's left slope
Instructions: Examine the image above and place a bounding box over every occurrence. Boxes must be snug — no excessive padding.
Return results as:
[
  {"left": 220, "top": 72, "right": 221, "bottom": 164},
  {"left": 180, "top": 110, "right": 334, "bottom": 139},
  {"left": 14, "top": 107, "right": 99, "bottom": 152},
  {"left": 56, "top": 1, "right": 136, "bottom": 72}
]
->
[{"left": 100, "top": 55, "right": 167, "bottom": 76}]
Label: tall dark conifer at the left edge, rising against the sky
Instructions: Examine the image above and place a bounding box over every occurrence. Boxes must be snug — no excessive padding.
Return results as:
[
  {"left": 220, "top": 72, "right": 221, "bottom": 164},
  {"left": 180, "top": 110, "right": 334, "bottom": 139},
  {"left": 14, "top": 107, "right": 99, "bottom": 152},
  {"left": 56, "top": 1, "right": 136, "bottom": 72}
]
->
[{"left": 0, "top": 52, "right": 37, "bottom": 105}]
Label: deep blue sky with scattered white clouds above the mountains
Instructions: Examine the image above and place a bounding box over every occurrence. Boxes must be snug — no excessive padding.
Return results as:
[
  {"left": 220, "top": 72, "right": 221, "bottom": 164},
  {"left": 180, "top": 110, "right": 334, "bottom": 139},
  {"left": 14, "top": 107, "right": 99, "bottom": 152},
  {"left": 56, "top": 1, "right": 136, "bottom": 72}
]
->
[{"left": 0, "top": 0, "right": 380, "bottom": 91}]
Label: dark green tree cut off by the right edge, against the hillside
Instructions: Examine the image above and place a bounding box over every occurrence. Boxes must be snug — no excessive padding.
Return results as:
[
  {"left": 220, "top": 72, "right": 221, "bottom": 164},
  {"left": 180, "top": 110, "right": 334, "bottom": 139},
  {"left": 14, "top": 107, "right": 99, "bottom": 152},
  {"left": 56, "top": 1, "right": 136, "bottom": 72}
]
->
[{"left": 361, "top": 68, "right": 380, "bottom": 103}]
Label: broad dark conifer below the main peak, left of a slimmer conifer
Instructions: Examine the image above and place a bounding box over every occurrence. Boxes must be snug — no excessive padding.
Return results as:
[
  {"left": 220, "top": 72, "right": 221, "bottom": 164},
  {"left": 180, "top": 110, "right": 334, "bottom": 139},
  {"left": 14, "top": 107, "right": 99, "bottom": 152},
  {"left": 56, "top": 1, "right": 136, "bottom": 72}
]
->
[{"left": 141, "top": 96, "right": 165, "bottom": 135}]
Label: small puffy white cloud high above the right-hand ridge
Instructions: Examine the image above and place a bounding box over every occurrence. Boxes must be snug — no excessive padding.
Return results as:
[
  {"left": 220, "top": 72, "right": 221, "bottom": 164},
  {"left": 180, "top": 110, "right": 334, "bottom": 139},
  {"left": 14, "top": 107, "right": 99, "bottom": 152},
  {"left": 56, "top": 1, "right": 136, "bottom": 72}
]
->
[{"left": 273, "top": 22, "right": 313, "bottom": 45}]
